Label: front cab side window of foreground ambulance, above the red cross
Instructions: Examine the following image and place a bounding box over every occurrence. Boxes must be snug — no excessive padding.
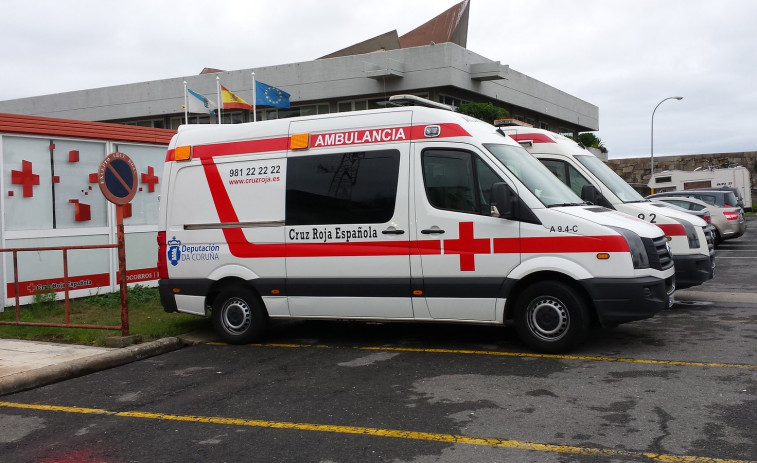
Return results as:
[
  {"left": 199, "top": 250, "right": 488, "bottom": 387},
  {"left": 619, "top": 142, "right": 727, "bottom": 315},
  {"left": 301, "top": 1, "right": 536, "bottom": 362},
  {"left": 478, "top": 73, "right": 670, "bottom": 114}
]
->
[{"left": 422, "top": 150, "right": 502, "bottom": 215}]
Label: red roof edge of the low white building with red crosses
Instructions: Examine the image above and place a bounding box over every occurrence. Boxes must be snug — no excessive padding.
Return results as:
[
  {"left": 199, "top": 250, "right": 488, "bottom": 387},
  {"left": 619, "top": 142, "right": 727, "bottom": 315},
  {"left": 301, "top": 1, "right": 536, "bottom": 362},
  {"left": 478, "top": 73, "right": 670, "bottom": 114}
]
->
[{"left": 0, "top": 113, "right": 176, "bottom": 145}]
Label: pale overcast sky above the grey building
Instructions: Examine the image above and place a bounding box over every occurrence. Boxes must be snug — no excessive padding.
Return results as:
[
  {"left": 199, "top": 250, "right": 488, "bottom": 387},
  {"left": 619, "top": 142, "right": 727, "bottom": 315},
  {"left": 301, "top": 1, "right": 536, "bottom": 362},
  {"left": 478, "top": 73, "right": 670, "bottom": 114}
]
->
[{"left": 0, "top": 0, "right": 757, "bottom": 159}]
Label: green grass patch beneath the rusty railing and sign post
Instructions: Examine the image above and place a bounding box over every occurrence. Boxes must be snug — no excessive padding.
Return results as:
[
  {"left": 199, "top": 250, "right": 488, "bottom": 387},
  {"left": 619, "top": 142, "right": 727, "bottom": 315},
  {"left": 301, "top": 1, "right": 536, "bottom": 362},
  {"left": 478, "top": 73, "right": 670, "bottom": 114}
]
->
[{"left": 0, "top": 285, "right": 210, "bottom": 346}]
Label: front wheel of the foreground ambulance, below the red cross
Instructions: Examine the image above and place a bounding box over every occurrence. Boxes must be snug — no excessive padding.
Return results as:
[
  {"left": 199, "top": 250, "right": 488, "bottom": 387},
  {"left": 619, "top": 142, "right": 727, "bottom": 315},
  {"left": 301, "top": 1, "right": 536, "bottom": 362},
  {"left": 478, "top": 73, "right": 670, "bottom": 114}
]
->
[{"left": 515, "top": 281, "right": 590, "bottom": 354}]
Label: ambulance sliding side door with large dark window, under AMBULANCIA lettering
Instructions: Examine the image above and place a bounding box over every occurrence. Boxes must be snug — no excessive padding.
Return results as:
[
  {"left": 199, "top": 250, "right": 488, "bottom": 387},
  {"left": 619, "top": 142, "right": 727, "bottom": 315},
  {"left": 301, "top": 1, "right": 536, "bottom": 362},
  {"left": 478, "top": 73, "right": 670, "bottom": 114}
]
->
[{"left": 286, "top": 113, "right": 413, "bottom": 319}]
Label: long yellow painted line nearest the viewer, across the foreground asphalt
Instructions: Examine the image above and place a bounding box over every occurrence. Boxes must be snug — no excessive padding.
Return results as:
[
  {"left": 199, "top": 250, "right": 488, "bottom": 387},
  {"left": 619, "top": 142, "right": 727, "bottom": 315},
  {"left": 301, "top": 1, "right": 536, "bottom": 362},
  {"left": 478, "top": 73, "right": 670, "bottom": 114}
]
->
[{"left": 0, "top": 402, "right": 757, "bottom": 463}]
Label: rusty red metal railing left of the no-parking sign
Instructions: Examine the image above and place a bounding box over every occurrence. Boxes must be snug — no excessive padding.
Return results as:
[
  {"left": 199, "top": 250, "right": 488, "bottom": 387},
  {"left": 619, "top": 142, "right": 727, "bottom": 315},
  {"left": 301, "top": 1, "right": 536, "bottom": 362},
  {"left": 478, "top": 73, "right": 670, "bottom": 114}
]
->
[{"left": 0, "top": 240, "right": 129, "bottom": 336}]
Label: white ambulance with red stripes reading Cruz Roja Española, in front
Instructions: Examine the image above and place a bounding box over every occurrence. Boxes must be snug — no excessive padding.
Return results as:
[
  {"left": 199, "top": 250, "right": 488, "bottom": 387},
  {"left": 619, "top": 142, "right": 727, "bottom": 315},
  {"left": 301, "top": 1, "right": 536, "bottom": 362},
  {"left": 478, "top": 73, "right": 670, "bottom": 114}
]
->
[{"left": 158, "top": 97, "right": 675, "bottom": 352}]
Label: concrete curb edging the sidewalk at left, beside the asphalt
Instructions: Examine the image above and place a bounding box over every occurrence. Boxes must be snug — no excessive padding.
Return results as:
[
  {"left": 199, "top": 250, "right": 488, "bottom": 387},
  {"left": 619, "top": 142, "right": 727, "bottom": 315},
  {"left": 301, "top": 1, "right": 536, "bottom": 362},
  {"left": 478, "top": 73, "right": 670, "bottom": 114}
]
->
[{"left": 0, "top": 338, "right": 184, "bottom": 396}]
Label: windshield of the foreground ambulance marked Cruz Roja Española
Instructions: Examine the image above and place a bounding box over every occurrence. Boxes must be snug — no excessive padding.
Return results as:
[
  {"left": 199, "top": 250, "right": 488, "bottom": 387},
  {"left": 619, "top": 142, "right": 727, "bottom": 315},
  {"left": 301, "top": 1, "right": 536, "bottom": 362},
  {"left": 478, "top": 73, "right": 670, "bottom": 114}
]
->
[{"left": 484, "top": 143, "right": 584, "bottom": 207}]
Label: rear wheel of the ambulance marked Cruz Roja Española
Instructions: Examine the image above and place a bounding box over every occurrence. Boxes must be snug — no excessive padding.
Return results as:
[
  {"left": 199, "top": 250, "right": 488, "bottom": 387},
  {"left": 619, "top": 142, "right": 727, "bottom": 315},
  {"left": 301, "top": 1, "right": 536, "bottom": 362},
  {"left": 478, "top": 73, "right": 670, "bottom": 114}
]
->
[{"left": 211, "top": 286, "right": 268, "bottom": 344}]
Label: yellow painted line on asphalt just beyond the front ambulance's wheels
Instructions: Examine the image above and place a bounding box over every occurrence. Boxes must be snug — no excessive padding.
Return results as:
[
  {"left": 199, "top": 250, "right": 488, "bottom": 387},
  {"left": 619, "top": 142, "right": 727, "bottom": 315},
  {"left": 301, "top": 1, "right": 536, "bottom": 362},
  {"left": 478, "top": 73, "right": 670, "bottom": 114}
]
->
[{"left": 248, "top": 343, "right": 757, "bottom": 370}]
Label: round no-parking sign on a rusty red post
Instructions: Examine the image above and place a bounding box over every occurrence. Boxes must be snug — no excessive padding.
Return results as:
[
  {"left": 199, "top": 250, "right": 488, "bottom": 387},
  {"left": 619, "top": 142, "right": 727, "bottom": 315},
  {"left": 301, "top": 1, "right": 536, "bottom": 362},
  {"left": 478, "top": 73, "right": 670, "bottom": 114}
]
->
[{"left": 97, "top": 151, "right": 138, "bottom": 336}]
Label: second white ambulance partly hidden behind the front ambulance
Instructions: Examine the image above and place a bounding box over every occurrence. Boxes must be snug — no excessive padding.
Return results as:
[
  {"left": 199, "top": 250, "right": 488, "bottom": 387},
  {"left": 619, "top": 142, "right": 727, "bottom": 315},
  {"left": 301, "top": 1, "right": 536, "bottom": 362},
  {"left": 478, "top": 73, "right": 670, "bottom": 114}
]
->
[{"left": 498, "top": 124, "right": 715, "bottom": 289}]
